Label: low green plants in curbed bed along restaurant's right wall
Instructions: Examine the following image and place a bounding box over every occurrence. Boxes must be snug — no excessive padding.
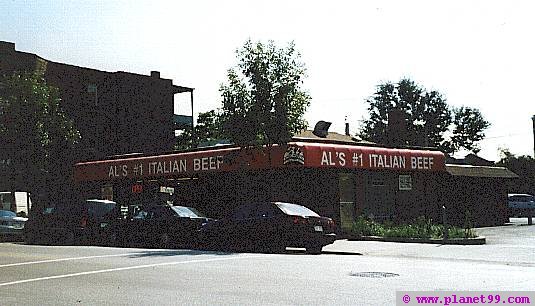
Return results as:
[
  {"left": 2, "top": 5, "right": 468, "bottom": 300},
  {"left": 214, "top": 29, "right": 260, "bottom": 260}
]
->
[{"left": 352, "top": 216, "right": 477, "bottom": 239}]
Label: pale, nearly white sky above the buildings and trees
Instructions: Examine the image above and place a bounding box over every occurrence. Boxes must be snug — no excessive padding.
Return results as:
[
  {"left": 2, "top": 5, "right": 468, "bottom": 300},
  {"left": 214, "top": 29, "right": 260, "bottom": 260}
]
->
[{"left": 0, "top": 0, "right": 535, "bottom": 160}]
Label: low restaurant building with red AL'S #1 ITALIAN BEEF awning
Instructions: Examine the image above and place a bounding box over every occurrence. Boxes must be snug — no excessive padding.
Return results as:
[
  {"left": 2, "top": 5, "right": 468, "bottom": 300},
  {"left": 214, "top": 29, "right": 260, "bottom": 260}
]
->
[{"left": 74, "top": 138, "right": 514, "bottom": 231}]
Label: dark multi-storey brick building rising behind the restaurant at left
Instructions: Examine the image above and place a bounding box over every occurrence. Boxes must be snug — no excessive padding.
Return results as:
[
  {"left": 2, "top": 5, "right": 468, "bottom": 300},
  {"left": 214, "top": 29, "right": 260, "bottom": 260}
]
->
[{"left": 0, "top": 41, "right": 193, "bottom": 159}]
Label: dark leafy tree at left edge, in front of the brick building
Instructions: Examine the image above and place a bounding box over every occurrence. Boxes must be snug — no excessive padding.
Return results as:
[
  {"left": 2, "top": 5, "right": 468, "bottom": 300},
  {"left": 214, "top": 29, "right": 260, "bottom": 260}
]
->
[{"left": 0, "top": 72, "right": 80, "bottom": 191}]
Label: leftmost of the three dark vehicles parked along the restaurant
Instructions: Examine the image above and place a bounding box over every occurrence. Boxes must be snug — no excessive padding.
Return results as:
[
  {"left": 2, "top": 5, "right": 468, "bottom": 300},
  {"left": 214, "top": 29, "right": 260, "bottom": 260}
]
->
[{"left": 24, "top": 199, "right": 122, "bottom": 245}]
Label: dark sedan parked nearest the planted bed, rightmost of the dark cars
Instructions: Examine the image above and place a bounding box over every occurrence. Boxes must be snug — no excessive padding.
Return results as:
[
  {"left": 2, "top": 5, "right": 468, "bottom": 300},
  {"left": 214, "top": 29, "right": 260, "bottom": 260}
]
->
[{"left": 201, "top": 202, "right": 336, "bottom": 254}]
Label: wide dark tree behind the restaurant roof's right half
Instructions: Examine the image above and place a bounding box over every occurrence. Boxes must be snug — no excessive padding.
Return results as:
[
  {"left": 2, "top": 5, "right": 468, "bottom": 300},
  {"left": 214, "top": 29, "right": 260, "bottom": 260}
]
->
[{"left": 359, "top": 79, "right": 489, "bottom": 153}]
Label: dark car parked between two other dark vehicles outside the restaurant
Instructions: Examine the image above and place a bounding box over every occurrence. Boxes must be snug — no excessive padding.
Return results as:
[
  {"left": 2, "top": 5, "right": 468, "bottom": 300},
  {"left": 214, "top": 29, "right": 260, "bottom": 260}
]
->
[{"left": 116, "top": 205, "right": 210, "bottom": 248}]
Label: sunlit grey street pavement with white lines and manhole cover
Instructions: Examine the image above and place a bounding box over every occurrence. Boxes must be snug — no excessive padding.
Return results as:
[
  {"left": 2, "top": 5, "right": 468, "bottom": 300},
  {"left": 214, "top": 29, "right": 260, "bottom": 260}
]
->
[{"left": 0, "top": 219, "right": 535, "bottom": 305}]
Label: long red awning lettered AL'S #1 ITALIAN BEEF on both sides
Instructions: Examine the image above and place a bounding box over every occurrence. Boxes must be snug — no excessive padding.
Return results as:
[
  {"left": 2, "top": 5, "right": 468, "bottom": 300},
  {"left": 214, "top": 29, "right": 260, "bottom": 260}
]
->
[{"left": 74, "top": 142, "right": 445, "bottom": 182}]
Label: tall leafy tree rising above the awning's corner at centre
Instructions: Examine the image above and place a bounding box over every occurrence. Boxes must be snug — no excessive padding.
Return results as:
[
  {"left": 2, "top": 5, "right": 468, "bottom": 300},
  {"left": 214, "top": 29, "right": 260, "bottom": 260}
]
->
[{"left": 220, "top": 40, "right": 311, "bottom": 146}]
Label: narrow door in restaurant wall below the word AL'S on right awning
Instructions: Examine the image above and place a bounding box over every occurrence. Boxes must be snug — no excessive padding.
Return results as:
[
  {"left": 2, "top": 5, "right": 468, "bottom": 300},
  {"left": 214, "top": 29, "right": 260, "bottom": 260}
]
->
[{"left": 338, "top": 173, "right": 357, "bottom": 232}]
